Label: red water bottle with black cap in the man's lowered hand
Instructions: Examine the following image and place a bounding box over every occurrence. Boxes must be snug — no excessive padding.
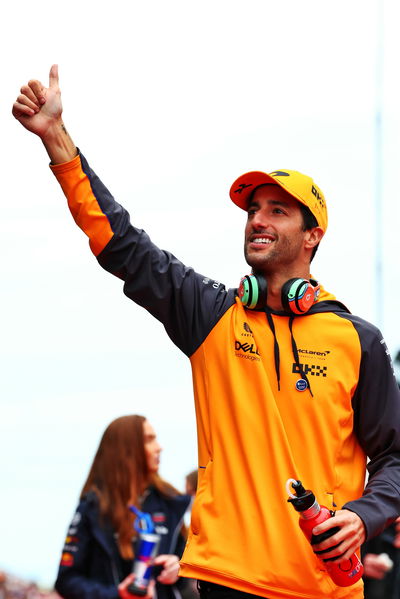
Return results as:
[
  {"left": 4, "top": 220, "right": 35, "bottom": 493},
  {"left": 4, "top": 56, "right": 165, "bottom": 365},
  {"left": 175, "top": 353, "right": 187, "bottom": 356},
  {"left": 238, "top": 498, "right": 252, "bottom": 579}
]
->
[{"left": 286, "top": 478, "right": 364, "bottom": 587}]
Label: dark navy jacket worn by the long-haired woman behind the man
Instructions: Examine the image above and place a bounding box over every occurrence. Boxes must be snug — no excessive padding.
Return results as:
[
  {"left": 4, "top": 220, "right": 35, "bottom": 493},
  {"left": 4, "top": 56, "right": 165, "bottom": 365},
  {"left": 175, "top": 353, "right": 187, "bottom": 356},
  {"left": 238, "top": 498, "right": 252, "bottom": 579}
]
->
[{"left": 55, "top": 487, "right": 190, "bottom": 599}]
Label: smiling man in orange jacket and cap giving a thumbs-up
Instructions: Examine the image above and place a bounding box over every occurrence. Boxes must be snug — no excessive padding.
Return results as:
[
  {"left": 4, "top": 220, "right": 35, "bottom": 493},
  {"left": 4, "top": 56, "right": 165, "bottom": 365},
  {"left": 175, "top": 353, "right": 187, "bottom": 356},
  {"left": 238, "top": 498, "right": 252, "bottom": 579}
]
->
[{"left": 13, "top": 66, "right": 400, "bottom": 599}]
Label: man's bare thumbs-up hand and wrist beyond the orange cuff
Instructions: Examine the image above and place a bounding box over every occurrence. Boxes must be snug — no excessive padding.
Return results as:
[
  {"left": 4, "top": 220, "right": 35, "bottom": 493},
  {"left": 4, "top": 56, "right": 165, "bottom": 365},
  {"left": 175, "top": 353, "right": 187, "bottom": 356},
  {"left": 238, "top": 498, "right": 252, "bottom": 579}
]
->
[{"left": 12, "top": 65, "right": 77, "bottom": 164}]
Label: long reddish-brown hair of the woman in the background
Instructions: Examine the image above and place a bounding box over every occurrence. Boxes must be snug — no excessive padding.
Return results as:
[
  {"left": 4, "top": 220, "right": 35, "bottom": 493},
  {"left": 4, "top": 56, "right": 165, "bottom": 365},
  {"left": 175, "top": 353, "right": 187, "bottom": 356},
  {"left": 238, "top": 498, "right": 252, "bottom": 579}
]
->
[{"left": 81, "top": 414, "right": 180, "bottom": 559}]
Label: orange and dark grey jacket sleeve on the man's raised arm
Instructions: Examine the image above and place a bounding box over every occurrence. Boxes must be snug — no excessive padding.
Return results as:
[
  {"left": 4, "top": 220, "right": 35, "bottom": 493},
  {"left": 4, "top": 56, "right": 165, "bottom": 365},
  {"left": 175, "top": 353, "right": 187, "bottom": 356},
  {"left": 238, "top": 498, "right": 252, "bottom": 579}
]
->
[{"left": 53, "top": 153, "right": 235, "bottom": 356}]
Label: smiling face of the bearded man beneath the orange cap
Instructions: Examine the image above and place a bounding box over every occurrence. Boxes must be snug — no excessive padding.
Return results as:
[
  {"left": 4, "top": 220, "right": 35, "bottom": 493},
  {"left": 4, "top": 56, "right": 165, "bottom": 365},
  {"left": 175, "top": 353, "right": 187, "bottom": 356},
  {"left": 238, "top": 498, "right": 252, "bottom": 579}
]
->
[{"left": 244, "top": 185, "right": 305, "bottom": 274}]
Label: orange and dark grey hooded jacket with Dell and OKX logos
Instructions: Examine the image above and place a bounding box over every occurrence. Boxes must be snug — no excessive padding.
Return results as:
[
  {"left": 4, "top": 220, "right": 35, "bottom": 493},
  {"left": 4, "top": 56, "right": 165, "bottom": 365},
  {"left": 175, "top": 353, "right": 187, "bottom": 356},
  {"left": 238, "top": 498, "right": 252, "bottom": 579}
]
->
[{"left": 52, "top": 155, "right": 400, "bottom": 599}]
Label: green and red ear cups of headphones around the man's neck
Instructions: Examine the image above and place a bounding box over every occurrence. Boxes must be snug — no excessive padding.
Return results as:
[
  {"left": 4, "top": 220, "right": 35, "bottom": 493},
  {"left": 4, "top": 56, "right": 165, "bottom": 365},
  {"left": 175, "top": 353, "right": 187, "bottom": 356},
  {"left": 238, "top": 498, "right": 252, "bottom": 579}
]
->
[{"left": 238, "top": 273, "right": 320, "bottom": 314}]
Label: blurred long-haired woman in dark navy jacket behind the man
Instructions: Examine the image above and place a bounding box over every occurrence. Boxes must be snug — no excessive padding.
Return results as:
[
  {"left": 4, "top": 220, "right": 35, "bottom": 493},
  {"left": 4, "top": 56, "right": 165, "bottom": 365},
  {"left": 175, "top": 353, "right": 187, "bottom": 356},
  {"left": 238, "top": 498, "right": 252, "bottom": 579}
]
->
[{"left": 55, "top": 415, "right": 190, "bottom": 599}]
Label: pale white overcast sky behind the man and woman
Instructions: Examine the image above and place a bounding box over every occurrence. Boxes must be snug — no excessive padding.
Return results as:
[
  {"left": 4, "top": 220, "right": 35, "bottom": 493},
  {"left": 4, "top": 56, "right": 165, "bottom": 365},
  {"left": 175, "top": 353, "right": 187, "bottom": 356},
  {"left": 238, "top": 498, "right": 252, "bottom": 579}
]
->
[{"left": 0, "top": 0, "right": 400, "bottom": 586}]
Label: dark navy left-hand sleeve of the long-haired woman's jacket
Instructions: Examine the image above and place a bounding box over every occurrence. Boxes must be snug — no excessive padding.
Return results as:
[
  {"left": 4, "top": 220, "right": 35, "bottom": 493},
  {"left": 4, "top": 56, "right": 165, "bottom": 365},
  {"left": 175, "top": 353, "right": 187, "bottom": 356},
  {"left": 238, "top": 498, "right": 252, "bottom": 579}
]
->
[{"left": 54, "top": 503, "right": 119, "bottom": 599}]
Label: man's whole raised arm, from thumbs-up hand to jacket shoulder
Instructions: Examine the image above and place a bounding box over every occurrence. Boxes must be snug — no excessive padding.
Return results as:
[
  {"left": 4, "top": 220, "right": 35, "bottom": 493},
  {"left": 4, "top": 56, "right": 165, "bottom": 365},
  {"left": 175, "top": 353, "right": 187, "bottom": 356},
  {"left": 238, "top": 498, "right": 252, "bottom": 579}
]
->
[{"left": 12, "top": 65, "right": 235, "bottom": 356}]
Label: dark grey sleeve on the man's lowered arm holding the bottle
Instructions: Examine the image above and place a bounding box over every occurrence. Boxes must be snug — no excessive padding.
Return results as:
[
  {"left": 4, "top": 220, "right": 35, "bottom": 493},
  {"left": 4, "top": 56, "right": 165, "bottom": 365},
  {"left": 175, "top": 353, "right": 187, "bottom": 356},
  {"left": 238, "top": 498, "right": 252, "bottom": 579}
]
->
[{"left": 343, "top": 315, "right": 400, "bottom": 539}]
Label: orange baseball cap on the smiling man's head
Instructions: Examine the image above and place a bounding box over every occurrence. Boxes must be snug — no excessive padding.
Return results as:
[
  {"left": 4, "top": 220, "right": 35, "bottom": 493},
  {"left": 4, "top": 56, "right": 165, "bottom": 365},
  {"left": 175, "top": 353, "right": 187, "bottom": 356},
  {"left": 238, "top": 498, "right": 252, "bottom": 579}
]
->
[{"left": 229, "top": 170, "right": 328, "bottom": 233}]
